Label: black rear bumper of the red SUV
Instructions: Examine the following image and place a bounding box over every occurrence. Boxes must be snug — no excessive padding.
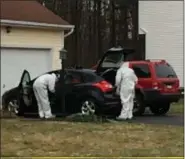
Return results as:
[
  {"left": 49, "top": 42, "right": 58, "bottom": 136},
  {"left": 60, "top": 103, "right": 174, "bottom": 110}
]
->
[{"left": 143, "top": 89, "right": 182, "bottom": 103}]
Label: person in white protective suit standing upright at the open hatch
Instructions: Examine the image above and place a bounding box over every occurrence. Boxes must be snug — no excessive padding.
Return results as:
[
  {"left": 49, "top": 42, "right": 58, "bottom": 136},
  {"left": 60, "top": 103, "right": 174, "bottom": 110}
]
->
[{"left": 115, "top": 62, "right": 138, "bottom": 120}]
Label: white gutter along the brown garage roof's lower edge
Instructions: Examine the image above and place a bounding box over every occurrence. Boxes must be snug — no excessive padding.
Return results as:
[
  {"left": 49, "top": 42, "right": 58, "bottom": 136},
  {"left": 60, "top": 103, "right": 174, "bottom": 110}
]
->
[{"left": 1, "top": 19, "right": 74, "bottom": 30}]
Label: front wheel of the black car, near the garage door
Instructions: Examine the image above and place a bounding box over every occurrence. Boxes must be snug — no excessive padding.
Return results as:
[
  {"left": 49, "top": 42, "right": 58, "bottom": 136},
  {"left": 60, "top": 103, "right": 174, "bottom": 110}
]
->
[{"left": 7, "top": 98, "right": 23, "bottom": 116}]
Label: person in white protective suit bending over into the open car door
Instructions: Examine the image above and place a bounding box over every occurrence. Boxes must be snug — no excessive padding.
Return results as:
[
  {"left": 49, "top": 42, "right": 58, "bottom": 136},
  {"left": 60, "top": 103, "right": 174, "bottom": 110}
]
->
[{"left": 33, "top": 73, "right": 58, "bottom": 119}]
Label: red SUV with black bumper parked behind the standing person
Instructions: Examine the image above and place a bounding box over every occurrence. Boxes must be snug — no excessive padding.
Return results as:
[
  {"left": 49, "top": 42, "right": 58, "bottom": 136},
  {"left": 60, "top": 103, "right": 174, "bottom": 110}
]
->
[{"left": 125, "top": 60, "right": 181, "bottom": 115}]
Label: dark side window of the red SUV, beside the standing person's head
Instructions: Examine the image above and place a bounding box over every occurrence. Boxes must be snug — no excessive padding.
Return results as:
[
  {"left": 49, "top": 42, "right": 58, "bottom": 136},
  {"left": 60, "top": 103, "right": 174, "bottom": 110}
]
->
[{"left": 132, "top": 64, "right": 151, "bottom": 78}]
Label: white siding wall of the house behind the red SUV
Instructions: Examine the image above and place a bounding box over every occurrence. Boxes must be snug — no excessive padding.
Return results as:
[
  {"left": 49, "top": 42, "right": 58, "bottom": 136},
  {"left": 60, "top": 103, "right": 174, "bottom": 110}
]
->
[{"left": 139, "top": 1, "right": 184, "bottom": 86}]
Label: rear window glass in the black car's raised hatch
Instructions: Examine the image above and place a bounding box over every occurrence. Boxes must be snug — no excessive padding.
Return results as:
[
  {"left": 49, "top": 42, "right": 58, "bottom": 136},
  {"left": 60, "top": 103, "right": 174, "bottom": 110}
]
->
[{"left": 101, "top": 51, "right": 124, "bottom": 68}]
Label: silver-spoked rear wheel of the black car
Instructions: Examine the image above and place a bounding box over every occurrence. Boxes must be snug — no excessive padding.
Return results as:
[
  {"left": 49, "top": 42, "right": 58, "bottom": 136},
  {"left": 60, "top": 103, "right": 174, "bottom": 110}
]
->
[{"left": 81, "top": 99, "right": 97, "bottom": 115}]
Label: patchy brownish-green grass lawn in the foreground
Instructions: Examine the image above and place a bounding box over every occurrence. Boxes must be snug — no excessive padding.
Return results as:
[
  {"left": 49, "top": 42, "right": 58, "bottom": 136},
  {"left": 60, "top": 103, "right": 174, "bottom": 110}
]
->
[{"left": 1, "top": 119, "right": 184, "bottom": 157}]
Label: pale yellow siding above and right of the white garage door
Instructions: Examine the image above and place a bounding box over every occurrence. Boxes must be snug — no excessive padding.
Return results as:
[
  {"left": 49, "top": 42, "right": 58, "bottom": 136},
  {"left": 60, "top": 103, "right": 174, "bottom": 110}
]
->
[{"left": 1, "top": 26, "right": 64, "bottom": 69}]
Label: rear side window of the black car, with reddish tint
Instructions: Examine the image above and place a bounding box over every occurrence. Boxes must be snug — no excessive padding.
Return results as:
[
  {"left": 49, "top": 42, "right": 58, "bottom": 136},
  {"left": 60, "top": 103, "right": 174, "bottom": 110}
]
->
[{"left": 65, "top": 72, "right": 83, "bottom": 84}]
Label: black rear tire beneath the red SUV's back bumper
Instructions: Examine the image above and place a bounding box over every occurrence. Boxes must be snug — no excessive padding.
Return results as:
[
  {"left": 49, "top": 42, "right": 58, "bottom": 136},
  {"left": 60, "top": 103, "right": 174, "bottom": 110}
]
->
[{"left": 150, "top": 103, "right": 170, "bottom": 115}]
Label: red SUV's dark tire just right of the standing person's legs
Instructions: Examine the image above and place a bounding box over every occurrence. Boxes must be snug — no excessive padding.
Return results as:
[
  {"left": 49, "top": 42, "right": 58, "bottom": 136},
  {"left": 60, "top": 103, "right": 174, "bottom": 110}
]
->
[{"left": 133, "top": 93, "right": 145, "bottom": 116}]
